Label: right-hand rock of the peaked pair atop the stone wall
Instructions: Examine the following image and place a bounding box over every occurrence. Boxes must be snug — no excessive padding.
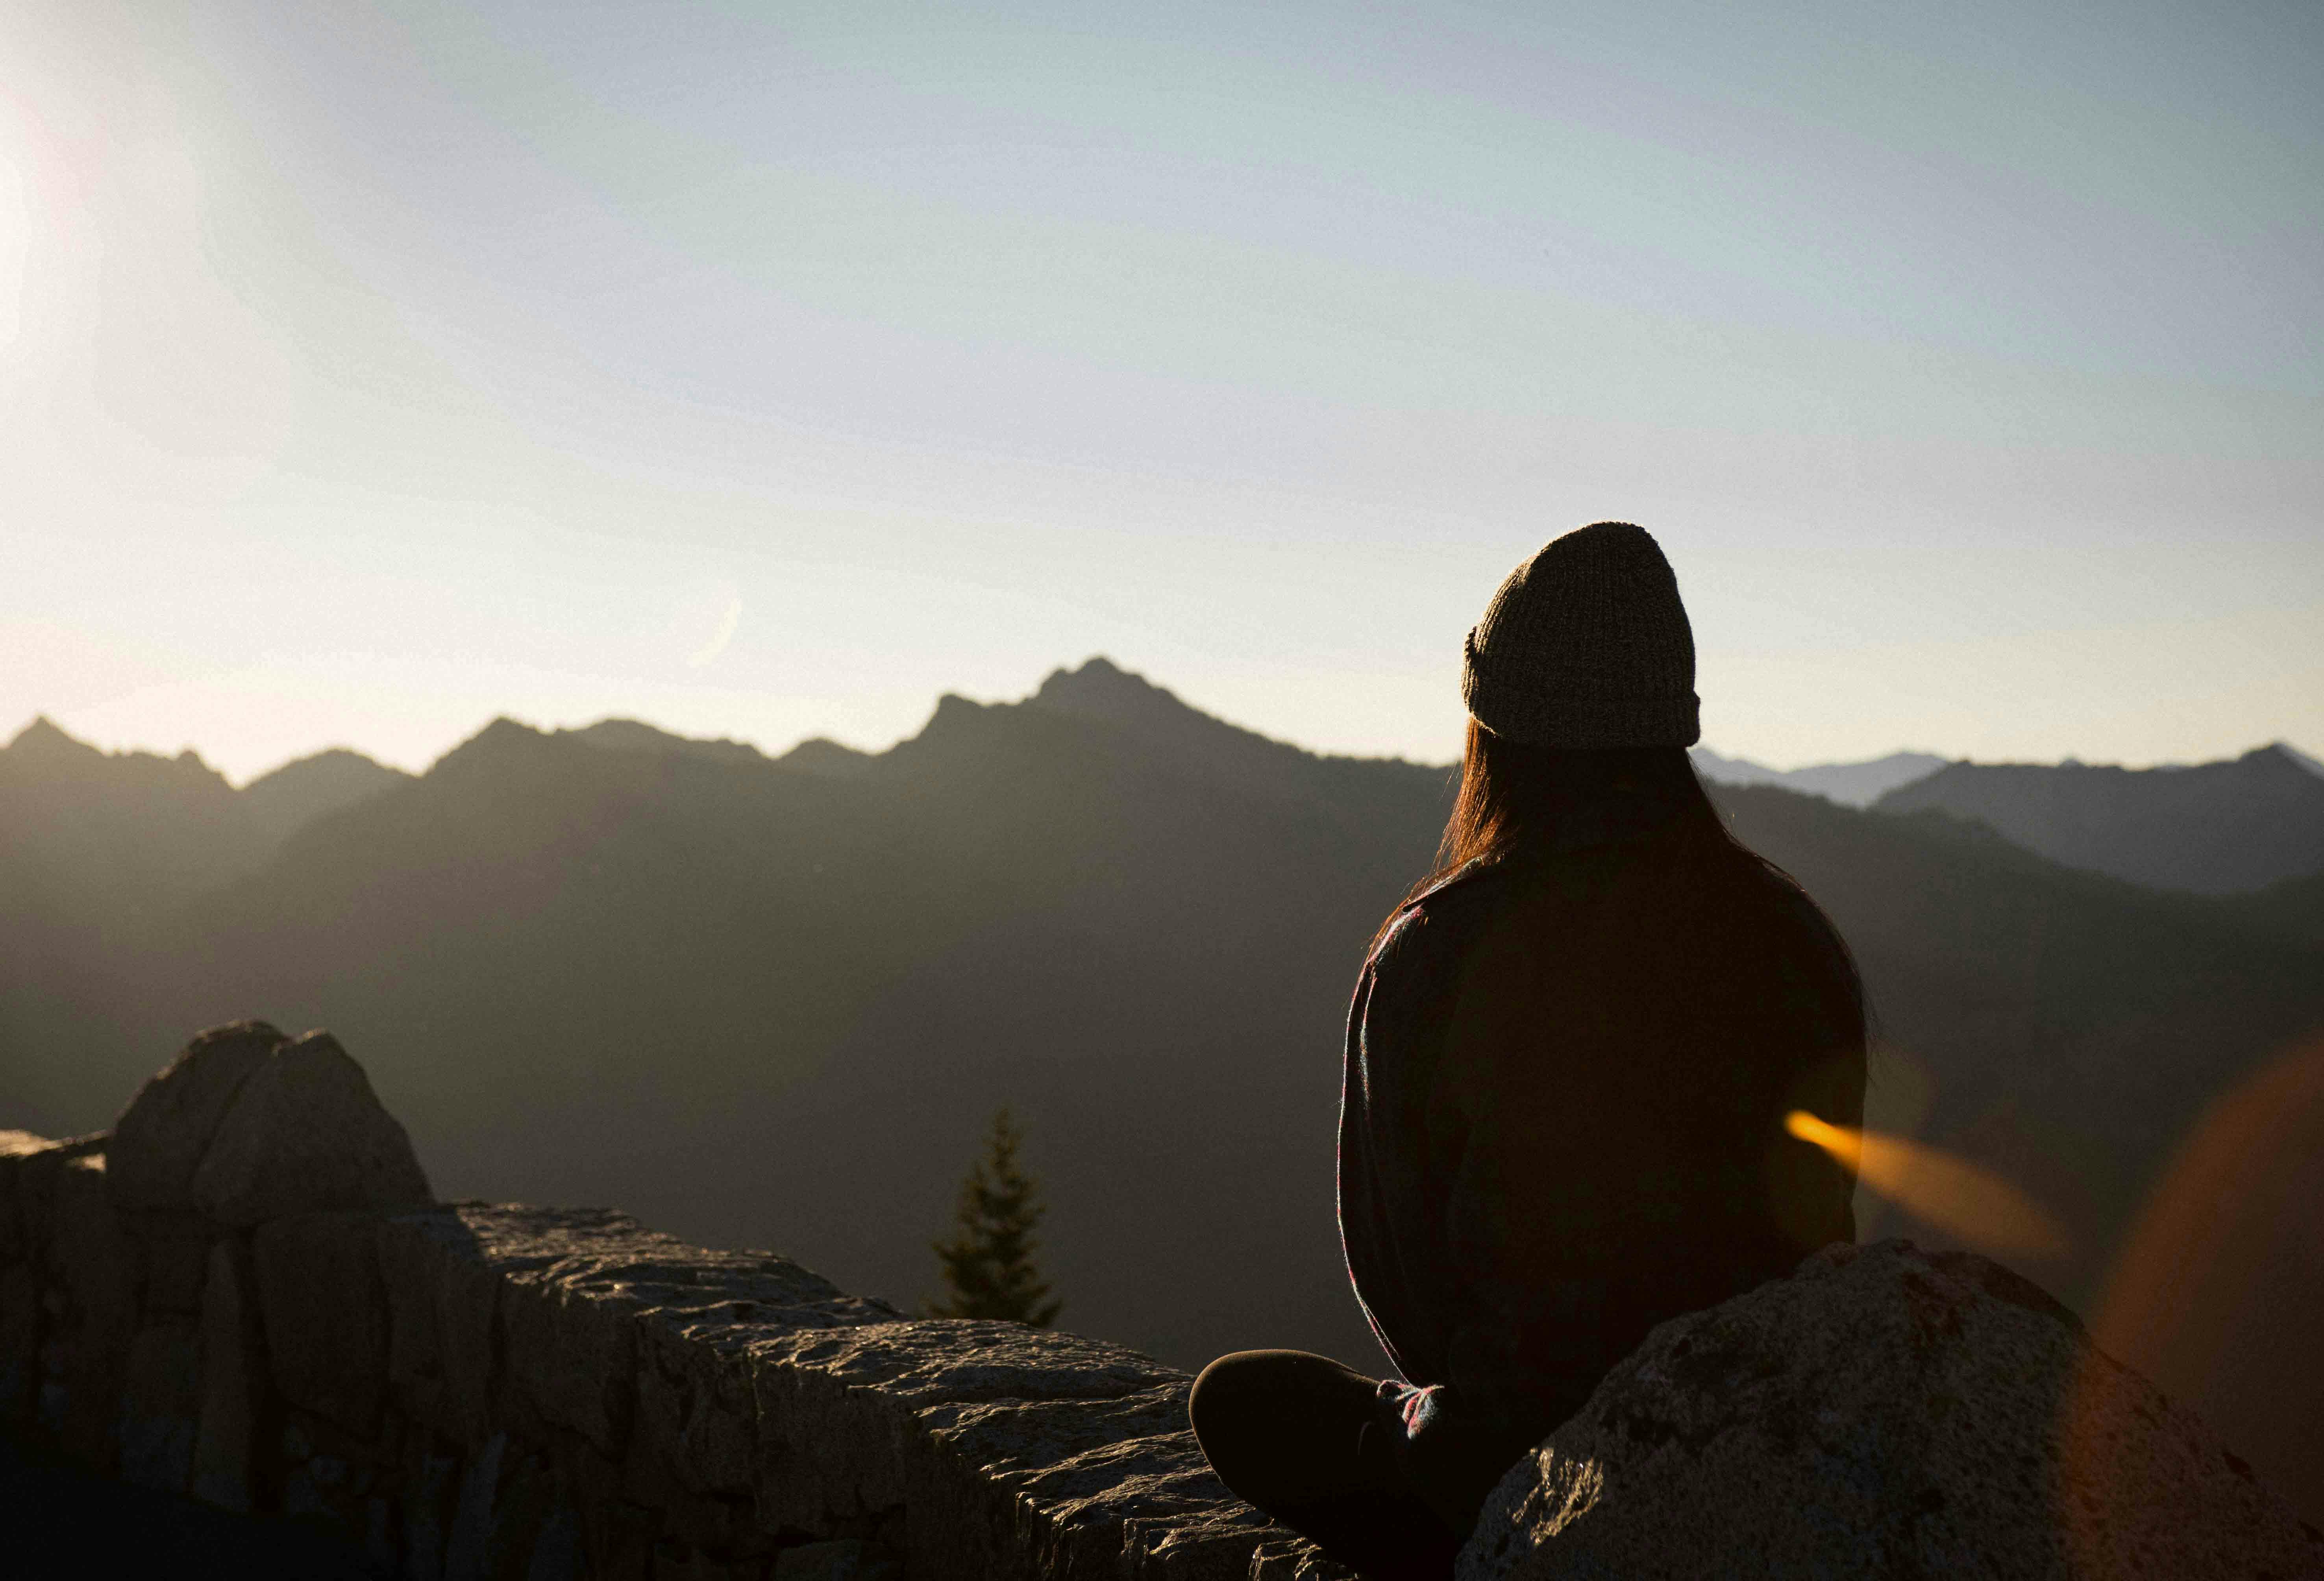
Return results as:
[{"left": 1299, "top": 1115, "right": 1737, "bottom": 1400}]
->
[{"left": 193, "top": 1032, "right": 435, "bottom": 1227}]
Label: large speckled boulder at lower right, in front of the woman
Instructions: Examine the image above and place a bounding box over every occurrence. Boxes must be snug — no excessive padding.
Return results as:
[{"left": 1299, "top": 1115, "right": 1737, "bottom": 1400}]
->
[{"left": 1457, "top": 1242, "right": 2324, "bottom": 1581}]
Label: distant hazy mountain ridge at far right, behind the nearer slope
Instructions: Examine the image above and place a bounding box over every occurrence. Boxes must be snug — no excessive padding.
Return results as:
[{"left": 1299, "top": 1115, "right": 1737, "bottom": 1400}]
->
[{"left": 1878, "top": 746, "right": 2324, "bottom": 895}]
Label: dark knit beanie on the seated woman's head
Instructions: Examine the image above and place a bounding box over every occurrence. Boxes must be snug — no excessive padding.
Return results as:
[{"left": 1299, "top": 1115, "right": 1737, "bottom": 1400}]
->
[{"left": 1462, "top": 521, "right": 1704, "bottom": 749}]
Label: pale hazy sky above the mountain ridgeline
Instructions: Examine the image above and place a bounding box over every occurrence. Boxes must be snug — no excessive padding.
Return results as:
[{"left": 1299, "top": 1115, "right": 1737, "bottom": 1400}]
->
[{"left": 0, "top": 0, "right": 2324, "bottom": 781}]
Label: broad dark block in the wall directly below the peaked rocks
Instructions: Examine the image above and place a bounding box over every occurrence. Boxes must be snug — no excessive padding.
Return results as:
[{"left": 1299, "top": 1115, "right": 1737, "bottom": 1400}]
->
[{"left": 251, "top": 1214, "right": 388, "bottom": 1437}]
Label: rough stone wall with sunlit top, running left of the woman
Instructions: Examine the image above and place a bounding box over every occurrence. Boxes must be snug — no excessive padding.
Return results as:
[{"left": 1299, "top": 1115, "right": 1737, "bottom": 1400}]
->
[{"left": 0, "top": 1023, "right": 1348, "bottom": 1581}]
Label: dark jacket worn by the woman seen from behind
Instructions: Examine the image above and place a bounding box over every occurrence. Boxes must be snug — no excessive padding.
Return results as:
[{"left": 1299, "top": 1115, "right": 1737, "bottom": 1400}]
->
[{"left": 1339, "top": 830, "right": 1864, "bottom": 1530}]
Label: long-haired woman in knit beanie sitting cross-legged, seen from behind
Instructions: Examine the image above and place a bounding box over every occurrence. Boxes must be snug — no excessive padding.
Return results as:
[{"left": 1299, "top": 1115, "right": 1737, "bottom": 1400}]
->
[{"left": 1190, "top": 521, "right": 1864, "bottom": 1576}]
